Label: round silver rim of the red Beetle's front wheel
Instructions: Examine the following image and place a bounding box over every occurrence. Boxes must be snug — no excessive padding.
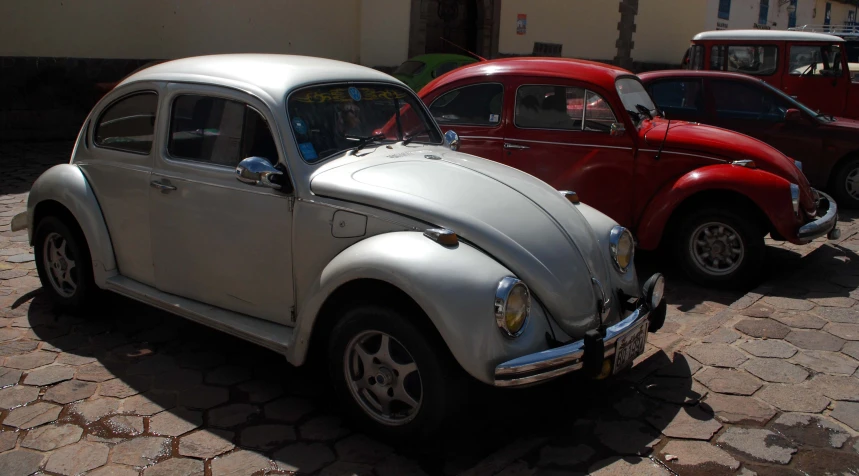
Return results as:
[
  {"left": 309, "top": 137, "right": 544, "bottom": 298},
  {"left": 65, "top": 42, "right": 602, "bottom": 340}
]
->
[{"left": 689, "top": 222, "right": 745, "bottom": 276}]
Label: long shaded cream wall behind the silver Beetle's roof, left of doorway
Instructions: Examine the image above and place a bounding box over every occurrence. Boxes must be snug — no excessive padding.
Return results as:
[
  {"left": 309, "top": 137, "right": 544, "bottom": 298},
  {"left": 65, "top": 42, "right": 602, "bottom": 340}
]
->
[{"left": 0, "top": 0, "right": 364, "bottom": 61}]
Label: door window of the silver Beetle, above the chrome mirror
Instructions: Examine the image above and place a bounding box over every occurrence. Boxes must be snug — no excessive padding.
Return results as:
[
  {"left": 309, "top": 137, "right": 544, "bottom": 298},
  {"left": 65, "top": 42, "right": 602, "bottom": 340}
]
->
[{"left": 173, "top": 95, "right": 278, "bottom": 167}]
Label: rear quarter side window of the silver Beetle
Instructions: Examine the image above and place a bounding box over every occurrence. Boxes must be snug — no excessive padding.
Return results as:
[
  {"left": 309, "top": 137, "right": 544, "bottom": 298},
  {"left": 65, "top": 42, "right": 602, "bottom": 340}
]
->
[{"left": 95, "top": 92, "right": 158, "bottom": 154}]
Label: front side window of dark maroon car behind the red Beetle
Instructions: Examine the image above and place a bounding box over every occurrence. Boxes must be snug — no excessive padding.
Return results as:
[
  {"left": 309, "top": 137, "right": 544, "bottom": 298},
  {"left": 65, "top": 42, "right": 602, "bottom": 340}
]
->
[{"left": 710, "top": 81, "right": 790, "bottom": 122}]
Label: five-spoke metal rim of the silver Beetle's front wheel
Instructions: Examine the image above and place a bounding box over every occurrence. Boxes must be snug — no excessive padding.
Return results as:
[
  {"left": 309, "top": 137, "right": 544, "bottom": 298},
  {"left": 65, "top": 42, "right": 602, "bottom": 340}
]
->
[{"left": 343, "top": 331, "right": 423, "bottom": 426}]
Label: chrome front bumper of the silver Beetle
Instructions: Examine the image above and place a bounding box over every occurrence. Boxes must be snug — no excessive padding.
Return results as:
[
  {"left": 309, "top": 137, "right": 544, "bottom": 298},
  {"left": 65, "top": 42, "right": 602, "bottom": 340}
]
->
[{"left": 495, "top": 302, "right": 665, "bottom": 387}]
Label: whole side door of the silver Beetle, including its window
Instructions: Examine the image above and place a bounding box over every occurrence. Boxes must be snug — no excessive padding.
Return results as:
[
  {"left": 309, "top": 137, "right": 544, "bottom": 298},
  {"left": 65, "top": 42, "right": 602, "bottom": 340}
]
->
[{"left": 149, "top": 84, "right": 293, "bottom": 324}]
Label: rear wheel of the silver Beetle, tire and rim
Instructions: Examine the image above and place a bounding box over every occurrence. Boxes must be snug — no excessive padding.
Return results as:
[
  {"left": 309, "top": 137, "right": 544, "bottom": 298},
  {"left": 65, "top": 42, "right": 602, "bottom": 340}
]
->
[{"left": 33, "top": 216, "right": 98, "bottom": 312}]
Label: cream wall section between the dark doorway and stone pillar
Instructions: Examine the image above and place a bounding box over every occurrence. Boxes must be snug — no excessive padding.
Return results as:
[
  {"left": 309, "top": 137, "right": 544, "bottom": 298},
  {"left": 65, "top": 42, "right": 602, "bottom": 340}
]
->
[{"left": 498, "top": 0, "right": 620, "bottom": 60}]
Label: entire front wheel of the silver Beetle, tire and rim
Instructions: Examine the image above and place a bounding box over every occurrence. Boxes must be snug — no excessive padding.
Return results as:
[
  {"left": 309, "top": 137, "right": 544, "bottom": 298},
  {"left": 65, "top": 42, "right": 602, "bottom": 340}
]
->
[{"left": 328, "top": 305, "right": 457, "bottom": 438}]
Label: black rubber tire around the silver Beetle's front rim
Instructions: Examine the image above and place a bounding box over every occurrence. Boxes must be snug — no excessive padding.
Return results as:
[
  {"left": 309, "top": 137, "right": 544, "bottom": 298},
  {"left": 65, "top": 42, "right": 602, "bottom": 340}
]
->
[{"left": 328, "top": 304, "right": 460, "bottom": 441}]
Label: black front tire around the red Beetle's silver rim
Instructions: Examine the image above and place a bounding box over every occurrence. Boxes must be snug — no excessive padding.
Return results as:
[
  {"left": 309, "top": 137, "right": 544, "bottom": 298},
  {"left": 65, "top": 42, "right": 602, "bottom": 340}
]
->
[{"left": 673, "top": 207, "right": 766, "bottom": 290}]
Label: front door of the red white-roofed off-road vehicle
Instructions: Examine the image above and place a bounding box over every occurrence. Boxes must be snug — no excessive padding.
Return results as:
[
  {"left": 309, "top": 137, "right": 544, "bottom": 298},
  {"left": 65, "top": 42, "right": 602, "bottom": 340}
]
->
[{"left": 782, "top": 43, "right": 850, "bottom": 116}]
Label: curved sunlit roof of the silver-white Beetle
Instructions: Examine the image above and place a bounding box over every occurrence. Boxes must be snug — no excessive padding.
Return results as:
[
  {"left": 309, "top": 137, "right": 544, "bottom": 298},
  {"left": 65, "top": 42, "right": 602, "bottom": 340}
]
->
[{"left": 120, "top": 54, "right": 400, "bottom": 101}]
